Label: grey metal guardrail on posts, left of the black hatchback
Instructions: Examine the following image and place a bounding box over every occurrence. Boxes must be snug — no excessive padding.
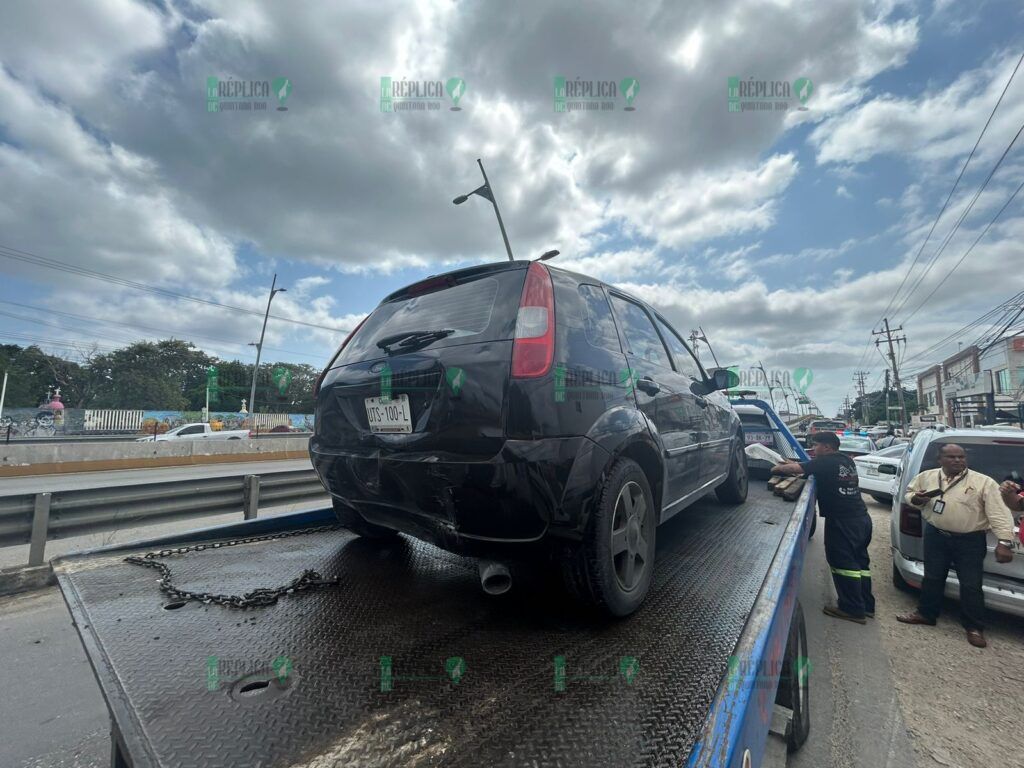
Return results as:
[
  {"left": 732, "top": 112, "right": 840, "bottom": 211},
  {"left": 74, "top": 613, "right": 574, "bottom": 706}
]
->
[{"left": 0, "top": 469, "right": 327, "bottom": 566}]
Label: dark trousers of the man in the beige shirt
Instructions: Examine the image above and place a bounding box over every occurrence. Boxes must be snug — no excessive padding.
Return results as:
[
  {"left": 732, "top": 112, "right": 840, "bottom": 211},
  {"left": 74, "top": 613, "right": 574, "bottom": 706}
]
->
[{"left": 918, "top": 522, "right": 987, "bottom": 630}]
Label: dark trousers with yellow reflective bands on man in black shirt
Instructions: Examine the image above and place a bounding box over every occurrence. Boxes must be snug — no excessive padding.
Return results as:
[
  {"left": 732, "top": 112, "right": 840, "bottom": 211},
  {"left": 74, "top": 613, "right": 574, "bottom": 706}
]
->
[{"left": 825, "top": 512, "right": 874, "bottom": 616}]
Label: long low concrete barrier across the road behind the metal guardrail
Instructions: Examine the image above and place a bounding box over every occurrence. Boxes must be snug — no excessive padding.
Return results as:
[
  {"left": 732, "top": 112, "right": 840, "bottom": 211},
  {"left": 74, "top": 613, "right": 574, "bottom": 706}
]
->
[{"left": 0, "top": 437, "right": 309, "bottom": 477}]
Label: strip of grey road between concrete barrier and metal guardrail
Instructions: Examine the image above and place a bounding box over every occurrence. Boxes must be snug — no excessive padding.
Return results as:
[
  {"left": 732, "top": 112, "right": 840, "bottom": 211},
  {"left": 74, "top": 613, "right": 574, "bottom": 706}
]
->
[{"left": 0, "top": 459, "right": 312, "bottom": 496}]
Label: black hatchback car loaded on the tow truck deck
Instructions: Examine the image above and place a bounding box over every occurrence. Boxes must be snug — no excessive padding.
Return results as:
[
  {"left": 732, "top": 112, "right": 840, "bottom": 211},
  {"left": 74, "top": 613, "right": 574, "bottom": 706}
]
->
[{"left": 309, "top": 261, "right": 748, "bottom": 615}]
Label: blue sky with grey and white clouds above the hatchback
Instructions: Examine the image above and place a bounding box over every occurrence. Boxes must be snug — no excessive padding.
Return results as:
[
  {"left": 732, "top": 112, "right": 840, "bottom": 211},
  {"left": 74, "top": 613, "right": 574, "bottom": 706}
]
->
[{"left": 0, "top": 0, "right": 1024, "bottom": 414}]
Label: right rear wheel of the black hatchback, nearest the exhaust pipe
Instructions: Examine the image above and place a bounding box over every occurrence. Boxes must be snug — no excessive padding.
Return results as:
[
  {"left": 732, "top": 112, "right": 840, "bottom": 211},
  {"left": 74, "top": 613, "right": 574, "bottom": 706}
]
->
[{"left": 562, "top": 459, "right": 657, "bottom": 616}]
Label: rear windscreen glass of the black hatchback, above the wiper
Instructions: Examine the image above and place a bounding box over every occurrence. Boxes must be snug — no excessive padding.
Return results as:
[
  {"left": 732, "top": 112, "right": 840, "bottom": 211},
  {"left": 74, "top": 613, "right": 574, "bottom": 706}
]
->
[{"left": 335, "top": 269, "right": 525, "bottom": 366}]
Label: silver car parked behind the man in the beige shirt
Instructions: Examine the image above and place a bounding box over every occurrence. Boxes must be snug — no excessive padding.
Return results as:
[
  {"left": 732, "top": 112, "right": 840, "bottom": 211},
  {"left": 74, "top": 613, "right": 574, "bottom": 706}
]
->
[{"left": 891, "top": 428, "right": 1024, "bottom": 616}]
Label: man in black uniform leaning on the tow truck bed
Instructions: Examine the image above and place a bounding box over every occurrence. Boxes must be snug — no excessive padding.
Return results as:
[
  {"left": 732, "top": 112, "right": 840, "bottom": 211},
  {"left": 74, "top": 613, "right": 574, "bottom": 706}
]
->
[{"left": 772, "top": 432, "right": 874, "bottom": 624}]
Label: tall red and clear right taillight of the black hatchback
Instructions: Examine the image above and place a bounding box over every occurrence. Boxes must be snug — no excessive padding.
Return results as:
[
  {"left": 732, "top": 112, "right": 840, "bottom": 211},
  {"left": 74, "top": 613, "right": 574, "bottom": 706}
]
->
[{"left": 512, "top": 261, "right": 555, "bottom": 379}]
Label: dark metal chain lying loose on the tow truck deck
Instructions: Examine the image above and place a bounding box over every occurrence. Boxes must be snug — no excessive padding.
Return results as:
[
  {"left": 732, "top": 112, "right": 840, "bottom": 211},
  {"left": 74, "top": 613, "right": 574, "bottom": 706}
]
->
[{"left": 125, "top": 525, "right": 340, "bottom": 608}]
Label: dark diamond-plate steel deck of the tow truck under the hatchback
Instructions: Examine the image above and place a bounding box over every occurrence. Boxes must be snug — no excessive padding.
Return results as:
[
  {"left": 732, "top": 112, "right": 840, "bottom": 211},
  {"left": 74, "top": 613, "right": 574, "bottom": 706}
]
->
[{"left": 55, "top": 486, "right": 794, "bottom": 768}]
